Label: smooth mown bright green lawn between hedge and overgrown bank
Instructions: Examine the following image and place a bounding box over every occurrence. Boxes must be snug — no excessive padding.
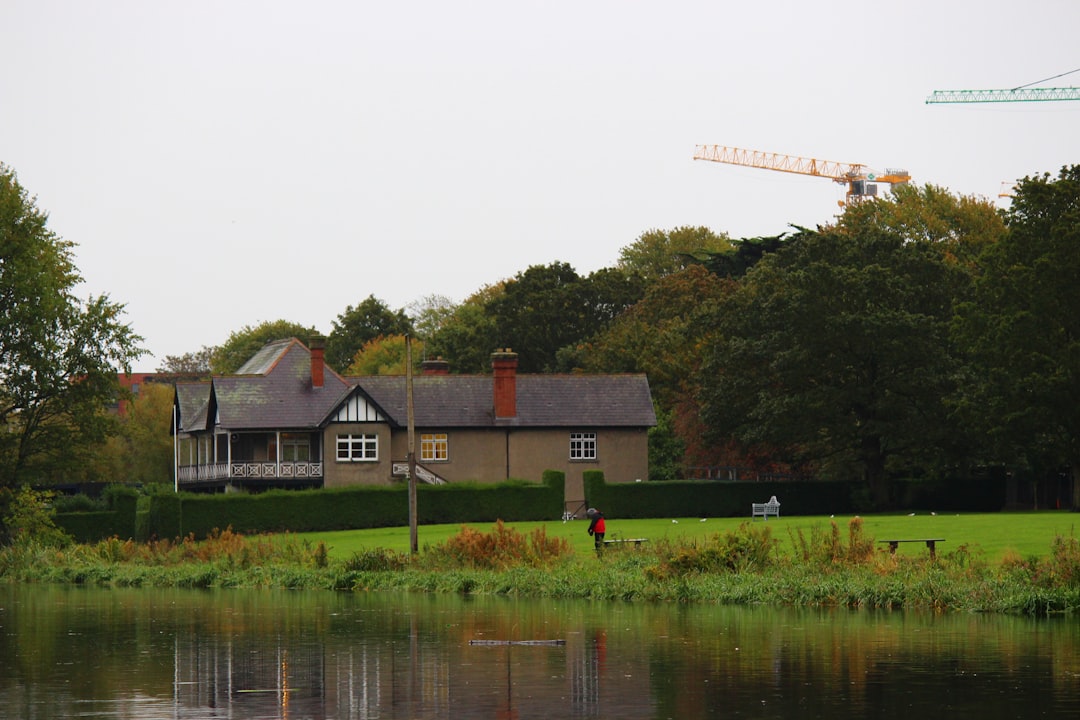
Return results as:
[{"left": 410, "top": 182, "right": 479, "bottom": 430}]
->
[{"left": 298, "top": 511, "right": 1080, "bottom": 561}]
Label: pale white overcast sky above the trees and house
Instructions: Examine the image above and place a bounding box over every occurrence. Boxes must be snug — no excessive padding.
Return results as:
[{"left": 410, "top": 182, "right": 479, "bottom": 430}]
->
[{"left": 0, "top": 0, "right": 1080, "bottom": 360}]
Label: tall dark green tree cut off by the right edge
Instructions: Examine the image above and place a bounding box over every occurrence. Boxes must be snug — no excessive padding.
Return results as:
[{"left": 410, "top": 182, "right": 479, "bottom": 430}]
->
[{"left": 956, "top": 165, "right": 1080, "bottom": 506}]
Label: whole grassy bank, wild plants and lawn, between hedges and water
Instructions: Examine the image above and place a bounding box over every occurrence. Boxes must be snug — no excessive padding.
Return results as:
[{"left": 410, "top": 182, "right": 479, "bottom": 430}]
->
[{"left": 0, "top": 513, "right": 1080, "bottom": 614}]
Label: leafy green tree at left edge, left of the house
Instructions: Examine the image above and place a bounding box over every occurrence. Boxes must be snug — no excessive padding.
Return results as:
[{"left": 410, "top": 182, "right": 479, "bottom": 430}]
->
[{"left": 0, "top": 165, "right": 143, "bottom": 486}]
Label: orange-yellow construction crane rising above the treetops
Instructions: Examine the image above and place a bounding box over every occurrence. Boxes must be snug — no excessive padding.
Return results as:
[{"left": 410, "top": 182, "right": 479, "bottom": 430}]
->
[{"left": 693, "top": 145, "right": 912, "bottom": 206}]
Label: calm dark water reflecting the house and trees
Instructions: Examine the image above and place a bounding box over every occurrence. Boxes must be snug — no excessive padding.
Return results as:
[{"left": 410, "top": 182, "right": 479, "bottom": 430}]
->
[{"left": 0, "top": 585, "right": 1080, "bottom": 720}]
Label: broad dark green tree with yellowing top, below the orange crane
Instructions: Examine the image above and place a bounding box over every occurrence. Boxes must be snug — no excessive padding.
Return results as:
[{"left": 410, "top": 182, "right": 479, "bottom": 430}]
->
[{"left": 702, "top": 187, "right": 1001, "bottom": 505}]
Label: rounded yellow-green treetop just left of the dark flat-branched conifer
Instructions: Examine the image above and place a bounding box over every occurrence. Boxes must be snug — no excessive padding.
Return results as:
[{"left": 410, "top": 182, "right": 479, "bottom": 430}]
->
[{"left": 618, "top": 227, "right": 731, "bottom": 283}]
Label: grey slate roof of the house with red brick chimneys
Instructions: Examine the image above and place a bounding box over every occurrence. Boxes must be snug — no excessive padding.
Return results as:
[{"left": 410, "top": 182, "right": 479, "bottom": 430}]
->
[{"left": 176, "top": 340, "right": 657, "bottom": 432}]
